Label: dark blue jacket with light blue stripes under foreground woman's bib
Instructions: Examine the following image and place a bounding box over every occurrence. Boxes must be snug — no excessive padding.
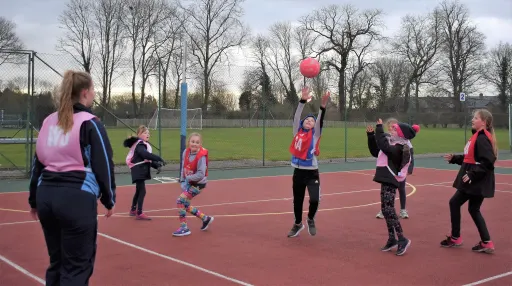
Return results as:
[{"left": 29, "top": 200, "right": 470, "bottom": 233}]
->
[{"left": 28, "top": 103, "right": 116, "bottom": 209}]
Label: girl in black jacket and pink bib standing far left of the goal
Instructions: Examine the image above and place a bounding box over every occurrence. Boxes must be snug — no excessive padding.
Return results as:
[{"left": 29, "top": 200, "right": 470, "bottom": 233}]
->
[{"left": 123, "top": 125, "right": 165, "bottom": 220}]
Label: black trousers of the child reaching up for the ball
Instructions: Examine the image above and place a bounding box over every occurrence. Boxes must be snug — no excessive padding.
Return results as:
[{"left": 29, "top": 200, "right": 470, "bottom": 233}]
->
[{"left": 293, "top": 168, "right": 320, "bottom": 224}]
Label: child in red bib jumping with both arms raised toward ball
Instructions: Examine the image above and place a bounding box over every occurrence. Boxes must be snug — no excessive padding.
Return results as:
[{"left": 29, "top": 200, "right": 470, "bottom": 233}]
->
[{"left": 288, "top": 87, "right": 330, "bottom": 237}]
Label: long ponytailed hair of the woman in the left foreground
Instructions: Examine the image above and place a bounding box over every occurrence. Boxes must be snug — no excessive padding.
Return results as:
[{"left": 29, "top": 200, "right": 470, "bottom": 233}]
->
[{"left": 57, "top": 70, "right": 92, "bottom": 133}]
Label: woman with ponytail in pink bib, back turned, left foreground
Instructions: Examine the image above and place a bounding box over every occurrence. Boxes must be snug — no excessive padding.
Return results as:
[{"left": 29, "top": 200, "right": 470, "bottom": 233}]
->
[{"left": 28, "top": 71, "right": 116, "bottom": 285}]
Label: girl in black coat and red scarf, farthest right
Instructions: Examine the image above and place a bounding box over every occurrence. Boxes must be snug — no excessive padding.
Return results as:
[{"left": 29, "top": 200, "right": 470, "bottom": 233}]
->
[{"left": 441, "top": 109, "right": 498, "bottom": 253}]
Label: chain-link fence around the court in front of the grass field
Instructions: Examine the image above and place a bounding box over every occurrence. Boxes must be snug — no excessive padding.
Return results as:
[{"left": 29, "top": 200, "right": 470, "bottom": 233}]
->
[{"left": 0, "top": 51, "right": 510, "bottom": 179}]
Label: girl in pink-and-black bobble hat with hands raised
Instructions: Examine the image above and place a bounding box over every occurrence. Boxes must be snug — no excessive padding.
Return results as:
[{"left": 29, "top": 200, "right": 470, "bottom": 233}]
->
[{"left": 367, "top": 119, "right": 416, "bottom": 256}]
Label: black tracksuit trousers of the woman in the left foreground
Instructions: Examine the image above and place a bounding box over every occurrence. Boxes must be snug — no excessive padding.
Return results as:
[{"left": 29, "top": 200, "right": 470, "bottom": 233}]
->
[{"left": 36, "top": 186, "right": 98, "bottom": 286}]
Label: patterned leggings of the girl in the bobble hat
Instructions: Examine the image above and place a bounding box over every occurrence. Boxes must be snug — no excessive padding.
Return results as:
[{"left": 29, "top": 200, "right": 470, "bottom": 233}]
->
[{"left": 380, "top": 184, "right": 404, "bottom": 240}]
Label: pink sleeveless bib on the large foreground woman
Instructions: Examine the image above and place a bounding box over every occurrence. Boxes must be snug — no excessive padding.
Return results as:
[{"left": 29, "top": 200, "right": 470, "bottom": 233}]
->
[{"left": 36, "top": 111, "right": 96, "bottom": 172}]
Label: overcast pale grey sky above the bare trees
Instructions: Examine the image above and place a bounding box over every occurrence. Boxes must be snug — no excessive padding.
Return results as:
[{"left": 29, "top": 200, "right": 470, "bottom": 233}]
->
[{"left": 0, "top": 0, "right": 512, "bottom": 54}]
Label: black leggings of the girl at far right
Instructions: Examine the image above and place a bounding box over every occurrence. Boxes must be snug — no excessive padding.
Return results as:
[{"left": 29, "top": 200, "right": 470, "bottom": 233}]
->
[{"left": 450, "top": 190, "right": 491, "bottom": 241}]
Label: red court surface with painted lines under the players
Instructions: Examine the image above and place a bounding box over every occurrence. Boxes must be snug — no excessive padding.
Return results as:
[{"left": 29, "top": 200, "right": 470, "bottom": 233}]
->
[{"left": 0, "top": 168, "right": 512, "bottom": 286}]
